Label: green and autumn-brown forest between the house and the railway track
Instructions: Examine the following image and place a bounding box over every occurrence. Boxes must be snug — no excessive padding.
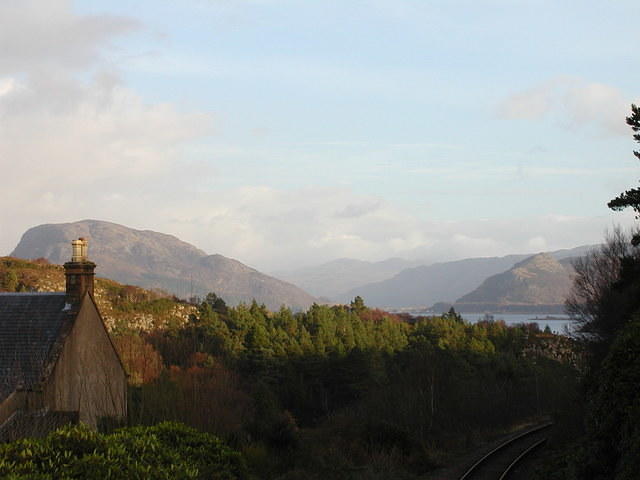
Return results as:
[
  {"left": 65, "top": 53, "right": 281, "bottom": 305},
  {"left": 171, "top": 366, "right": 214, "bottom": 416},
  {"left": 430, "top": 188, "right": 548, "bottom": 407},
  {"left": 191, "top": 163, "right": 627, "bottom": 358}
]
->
[{"left": 116, "top": 293, "right": 580, "bottom": 479}]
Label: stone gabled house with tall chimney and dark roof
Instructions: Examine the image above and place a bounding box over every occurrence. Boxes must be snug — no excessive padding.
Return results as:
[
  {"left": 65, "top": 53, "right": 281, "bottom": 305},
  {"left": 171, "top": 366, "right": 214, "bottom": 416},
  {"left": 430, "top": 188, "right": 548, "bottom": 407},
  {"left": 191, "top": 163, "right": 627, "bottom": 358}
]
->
[{"left": 0, "top": 238, "right": 127, "bottom": 441}]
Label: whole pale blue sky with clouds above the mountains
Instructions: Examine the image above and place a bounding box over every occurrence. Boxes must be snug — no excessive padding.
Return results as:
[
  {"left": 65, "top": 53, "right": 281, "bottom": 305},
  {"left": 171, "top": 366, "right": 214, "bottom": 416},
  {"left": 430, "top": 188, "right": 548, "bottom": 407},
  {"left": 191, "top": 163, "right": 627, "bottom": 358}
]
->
[{"left": 0, "top": 0, "right": 640, "bottom": 272}]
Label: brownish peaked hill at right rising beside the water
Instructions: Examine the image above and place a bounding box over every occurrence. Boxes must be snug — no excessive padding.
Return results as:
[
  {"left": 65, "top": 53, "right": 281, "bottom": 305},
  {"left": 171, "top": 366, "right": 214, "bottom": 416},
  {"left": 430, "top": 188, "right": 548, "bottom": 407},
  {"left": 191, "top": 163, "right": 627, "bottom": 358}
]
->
[{"left": 454, "top": 253, "right": 574, "bottom": 312}]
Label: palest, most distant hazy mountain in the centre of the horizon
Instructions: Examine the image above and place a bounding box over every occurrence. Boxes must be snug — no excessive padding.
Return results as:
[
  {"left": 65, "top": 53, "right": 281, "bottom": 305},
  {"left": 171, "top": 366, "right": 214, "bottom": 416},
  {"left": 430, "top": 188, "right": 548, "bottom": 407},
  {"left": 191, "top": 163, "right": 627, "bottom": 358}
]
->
[{"left": 274, "top": 258, "right": 420, "bottom": 299}]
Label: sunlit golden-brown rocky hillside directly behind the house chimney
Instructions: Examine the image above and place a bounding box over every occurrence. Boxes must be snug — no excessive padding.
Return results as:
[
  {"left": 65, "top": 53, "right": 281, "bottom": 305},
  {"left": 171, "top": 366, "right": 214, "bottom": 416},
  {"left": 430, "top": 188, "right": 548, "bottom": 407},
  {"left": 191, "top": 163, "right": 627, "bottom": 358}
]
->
[{"left": 0, "top": 257, "right": 196, "bottom": 332}]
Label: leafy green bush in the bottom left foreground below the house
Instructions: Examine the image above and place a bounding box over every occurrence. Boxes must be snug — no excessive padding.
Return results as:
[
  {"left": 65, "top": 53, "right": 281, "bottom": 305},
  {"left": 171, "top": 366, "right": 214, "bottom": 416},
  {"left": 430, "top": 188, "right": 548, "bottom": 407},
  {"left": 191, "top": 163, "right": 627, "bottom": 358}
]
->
[{"left": 0, "top": 422, "right": 246, "bottom": 480}]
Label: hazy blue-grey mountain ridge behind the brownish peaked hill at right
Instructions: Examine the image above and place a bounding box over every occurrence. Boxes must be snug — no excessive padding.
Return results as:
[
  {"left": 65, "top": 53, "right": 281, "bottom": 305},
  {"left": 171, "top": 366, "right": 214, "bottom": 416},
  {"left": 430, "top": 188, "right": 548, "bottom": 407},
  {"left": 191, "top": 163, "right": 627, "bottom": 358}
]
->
[{"left": 337, "top": 245, "right": 594, "bottom": 308}]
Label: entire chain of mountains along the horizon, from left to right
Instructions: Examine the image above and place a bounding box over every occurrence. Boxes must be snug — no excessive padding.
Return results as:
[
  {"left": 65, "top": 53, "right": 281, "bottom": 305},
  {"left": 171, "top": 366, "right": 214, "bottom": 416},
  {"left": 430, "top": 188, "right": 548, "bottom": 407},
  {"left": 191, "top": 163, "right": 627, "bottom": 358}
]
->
[{"left": 11, "top": 220, "right": 593, "bottom": 311}]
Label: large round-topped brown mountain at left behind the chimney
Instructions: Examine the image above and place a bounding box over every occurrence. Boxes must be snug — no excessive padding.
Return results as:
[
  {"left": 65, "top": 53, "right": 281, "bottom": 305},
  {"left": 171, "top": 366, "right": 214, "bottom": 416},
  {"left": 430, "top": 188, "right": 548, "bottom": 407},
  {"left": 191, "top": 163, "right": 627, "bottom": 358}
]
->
[{"left": 11, "top": 220, "right": 315, "bottom": 309}]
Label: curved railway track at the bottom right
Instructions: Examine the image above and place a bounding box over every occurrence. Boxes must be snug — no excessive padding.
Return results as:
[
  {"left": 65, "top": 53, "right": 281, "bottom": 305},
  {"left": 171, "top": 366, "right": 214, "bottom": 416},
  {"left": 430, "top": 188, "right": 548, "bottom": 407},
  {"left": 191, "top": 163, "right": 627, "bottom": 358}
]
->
[{"left": 459, "top": 422, "right": 553, "bottom": 480}]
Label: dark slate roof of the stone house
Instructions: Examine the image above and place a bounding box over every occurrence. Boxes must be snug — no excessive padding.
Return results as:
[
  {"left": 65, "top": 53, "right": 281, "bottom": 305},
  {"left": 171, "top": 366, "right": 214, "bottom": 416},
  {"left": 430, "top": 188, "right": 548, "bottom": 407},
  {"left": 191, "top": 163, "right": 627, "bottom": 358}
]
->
[{"left": 0, "top": 293, "right": 72, "bottom": 403}]
